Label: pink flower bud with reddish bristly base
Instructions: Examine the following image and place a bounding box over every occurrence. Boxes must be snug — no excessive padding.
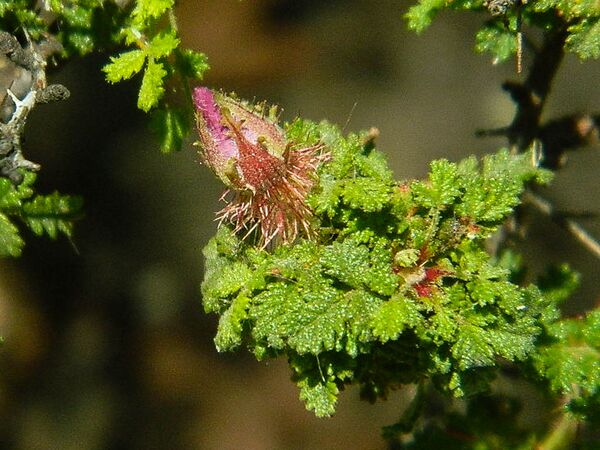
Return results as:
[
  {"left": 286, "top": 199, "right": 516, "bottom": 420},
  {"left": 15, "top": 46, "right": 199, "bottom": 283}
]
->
[{"left": 193, "top": 87, "right": 328, "bottom": 247}]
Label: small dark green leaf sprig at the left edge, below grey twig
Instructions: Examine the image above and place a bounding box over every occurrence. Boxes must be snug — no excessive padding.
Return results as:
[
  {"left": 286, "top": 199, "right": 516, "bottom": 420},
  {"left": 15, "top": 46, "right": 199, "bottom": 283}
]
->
[{"left": 0, "top": 173, "right": 81, "bottom": 256}]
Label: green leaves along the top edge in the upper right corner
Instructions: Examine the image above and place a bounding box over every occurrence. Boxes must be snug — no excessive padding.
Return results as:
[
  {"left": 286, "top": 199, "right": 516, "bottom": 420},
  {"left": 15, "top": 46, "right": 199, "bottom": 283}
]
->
[{"left": 406, "top": 0, "right": 600, "bottom": 62}]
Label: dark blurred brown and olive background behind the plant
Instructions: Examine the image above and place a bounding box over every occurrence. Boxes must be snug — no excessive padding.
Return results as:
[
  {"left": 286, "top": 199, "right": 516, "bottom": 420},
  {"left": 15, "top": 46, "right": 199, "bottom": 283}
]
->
[{"left": 0, "top": 0, "right": 600, "bottom": 450}]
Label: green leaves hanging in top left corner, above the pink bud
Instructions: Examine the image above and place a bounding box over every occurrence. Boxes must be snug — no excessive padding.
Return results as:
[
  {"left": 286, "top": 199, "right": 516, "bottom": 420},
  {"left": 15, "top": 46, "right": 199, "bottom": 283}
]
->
[{"left": 0, "top": 0, "right": 208, "bottom": 152}]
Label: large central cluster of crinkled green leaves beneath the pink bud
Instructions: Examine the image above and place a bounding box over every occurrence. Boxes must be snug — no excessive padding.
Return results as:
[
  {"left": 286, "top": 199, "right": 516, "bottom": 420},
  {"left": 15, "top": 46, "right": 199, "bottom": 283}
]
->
[{"left": 202, "top": 120, "right": 555, "bottom": 416}]
